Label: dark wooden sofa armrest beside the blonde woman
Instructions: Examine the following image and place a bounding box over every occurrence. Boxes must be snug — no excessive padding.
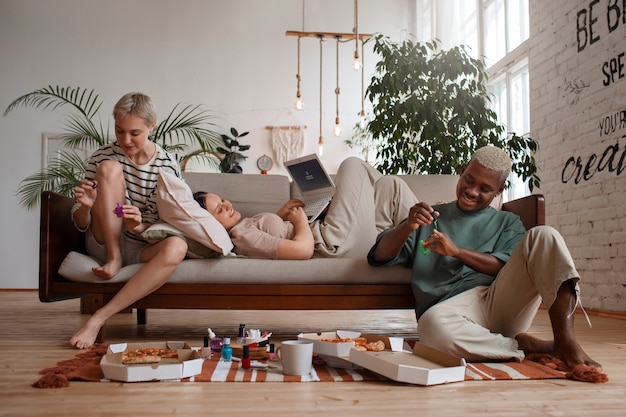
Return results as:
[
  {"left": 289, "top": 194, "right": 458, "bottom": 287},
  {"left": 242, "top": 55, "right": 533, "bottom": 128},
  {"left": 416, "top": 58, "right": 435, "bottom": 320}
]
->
[{"left": 39, "top": 191, "right": 85, "bottom": 301}]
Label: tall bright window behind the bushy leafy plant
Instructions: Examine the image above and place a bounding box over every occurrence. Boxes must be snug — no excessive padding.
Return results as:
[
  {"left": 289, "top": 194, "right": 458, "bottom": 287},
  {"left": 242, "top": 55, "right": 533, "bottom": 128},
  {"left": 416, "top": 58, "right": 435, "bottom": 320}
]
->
[{"left": 416, "top": 0, "right": 530, "bottom": 200}]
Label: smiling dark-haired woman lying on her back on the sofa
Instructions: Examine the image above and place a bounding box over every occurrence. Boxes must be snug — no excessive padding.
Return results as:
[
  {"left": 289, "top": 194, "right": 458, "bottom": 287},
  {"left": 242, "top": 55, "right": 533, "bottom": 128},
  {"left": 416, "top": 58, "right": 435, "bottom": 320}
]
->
[{"left": 194, "top": 157, "right": 418, "bottom": 259}]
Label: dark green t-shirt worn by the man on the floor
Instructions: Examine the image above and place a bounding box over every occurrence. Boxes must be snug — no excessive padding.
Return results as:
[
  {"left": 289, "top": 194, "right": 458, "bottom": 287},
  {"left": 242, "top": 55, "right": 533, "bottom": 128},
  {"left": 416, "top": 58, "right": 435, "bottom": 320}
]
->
[{"left": 368, "top": 202, "right": 526, "bottom": 319}]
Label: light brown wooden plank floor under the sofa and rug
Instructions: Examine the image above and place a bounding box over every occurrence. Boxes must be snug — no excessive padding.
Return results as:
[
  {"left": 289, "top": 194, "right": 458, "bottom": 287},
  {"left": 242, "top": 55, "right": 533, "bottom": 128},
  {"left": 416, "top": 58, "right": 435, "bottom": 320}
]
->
[{"left": 0, "top": 291, "right": 626, "bottom": 417}]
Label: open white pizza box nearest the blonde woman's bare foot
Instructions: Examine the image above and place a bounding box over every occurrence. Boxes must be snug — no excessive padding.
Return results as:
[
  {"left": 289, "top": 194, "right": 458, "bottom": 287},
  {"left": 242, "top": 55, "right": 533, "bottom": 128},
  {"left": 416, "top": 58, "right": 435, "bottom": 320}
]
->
[{"left": 100, "top": 341, "right": 203, "bottom": 382}]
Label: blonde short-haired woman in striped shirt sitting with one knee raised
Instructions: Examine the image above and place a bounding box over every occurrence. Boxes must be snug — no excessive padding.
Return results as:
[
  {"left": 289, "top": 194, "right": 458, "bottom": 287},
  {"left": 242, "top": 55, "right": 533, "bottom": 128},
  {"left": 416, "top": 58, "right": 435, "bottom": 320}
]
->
[{"left": 69, "top": 93, "right": 187, "bottom": 349}]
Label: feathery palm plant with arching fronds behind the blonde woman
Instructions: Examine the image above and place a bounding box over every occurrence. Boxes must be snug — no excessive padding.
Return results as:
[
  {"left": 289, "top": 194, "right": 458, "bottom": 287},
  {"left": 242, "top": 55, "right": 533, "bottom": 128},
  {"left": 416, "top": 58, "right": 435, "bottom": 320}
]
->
[{"left": 4, "top": 86, "right": 222, "bottom": 209}]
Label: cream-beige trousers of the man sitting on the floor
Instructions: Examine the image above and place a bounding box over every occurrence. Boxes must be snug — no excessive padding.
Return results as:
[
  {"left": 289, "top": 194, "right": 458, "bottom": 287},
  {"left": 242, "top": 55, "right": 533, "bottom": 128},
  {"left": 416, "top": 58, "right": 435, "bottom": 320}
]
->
[{"left": 418, "top": 226, "right": 579, "bottom": 362}]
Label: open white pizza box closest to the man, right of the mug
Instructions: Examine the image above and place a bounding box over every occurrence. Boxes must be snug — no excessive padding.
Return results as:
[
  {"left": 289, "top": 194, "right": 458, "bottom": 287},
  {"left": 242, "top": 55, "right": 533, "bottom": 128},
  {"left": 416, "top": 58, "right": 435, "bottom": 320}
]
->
[{"left": 349, "top": 335, "right": 466, "bottom": 385}]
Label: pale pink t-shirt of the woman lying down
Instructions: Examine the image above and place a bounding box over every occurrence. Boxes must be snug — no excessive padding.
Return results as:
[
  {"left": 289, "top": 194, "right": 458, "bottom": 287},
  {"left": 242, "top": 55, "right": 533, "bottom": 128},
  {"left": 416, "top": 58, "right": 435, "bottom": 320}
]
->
[{"left": 230, "top": 213, "right": 295, "bottom": 259}]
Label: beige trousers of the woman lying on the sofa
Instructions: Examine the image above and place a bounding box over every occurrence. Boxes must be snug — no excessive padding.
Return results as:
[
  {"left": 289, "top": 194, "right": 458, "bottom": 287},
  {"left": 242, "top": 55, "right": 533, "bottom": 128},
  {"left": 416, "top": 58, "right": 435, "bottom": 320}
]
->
[{"left": 311, "top": 157, "right": 418, "bottom": 258}]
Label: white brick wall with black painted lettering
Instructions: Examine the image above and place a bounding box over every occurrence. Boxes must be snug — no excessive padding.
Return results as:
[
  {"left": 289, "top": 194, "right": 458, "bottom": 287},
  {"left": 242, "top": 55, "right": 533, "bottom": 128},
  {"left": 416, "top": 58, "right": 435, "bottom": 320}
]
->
[{"left": 529, "top": 0, "right": 626, "bottom": 311}]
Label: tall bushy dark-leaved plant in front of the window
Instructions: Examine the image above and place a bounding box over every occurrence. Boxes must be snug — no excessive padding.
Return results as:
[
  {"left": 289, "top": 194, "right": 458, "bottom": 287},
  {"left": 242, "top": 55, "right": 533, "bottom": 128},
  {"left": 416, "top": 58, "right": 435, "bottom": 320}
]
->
[{"left": 363, "top": 34, "right": 540, "bottom": 191}]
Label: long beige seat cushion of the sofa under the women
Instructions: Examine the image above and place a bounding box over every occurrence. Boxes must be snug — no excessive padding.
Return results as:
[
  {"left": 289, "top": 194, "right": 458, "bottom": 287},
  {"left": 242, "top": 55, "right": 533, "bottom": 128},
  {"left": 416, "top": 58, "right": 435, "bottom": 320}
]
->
[{"left": 59, "top": 252, "right": 411, "bottom": 285}]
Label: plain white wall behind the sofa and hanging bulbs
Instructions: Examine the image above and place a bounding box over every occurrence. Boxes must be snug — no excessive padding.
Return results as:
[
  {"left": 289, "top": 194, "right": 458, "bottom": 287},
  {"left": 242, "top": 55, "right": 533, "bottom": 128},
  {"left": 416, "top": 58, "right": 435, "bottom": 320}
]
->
[{"left": 0, "top": 0, "right": 412, "bottom": 288}]
